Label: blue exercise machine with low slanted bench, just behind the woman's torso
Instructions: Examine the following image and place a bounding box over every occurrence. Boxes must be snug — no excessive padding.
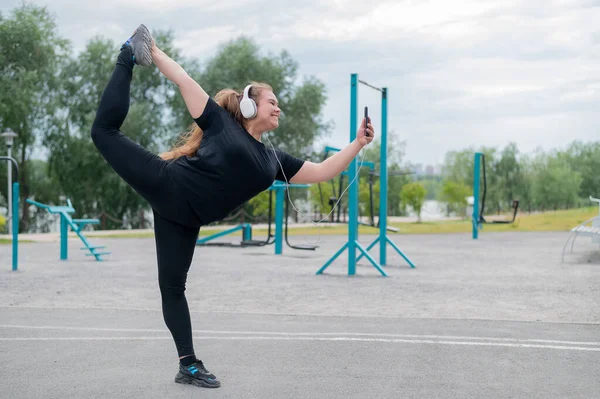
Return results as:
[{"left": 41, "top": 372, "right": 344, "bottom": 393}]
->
[{"left": 196, "top": 181, "right": 318, "bottom": 255}]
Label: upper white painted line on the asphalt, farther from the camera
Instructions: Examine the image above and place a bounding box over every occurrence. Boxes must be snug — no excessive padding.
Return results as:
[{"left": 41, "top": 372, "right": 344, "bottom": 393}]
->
[{"left": 0, "top": 324, "right": 600, "bottom": 346}]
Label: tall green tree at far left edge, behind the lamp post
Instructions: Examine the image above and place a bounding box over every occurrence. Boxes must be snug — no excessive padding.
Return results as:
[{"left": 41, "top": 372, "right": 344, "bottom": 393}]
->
[{"left": 0, "top": 4, "right": 67, "bottom": 230}]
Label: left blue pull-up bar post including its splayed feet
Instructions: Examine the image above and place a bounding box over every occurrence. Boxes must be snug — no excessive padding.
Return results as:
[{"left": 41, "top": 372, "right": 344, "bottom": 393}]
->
[{"left": 316, "top": 74, "right": 387, "bottom": 276}]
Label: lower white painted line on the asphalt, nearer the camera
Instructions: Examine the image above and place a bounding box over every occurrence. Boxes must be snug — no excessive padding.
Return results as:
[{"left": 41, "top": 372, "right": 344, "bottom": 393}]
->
[{"left": 0, "top": 336, "right": 600, "bottom": 352}]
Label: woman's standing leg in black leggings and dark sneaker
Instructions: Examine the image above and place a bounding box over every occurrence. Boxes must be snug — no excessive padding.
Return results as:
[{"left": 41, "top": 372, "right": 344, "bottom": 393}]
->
[{"left": 154, "top": 212, "right": 220, "bottom": 388}]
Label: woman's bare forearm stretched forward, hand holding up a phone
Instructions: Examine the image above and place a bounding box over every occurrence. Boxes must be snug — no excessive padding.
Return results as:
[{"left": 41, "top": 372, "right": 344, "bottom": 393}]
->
[{"left": 290, "top": 119, "right": 375, "bottom": 184}]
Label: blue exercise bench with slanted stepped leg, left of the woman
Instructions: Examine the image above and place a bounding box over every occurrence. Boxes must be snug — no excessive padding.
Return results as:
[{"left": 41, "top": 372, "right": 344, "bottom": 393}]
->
[{"left": 25, "top": 198, "right": 110, "bottom": 261}]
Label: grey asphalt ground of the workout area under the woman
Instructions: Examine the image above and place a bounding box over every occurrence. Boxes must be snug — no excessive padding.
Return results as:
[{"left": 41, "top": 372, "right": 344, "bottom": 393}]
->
[{"left": 0, "top": 232, "right": 600, "bottom": 399}]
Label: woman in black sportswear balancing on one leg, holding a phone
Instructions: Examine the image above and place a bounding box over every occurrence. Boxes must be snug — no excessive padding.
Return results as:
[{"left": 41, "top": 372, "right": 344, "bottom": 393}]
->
[{"left": 91, "top": 25, "right": 373, "bottom": 388}]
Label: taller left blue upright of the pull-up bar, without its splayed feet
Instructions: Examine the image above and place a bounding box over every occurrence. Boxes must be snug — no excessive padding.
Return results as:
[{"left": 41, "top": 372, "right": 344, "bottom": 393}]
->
[{"left": 348, "top": 73, "right": 358, "bottom": 276}]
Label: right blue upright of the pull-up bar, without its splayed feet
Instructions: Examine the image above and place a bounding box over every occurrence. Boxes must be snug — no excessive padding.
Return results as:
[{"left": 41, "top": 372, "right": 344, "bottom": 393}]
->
[{"left": 379, "top": 87, "right": 387, "bottom": 266}]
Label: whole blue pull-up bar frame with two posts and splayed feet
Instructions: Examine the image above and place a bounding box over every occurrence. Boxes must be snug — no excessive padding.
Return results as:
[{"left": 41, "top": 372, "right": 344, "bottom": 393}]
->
[{"left": 317, "top": 74, "right": 415, "bottom": 276}]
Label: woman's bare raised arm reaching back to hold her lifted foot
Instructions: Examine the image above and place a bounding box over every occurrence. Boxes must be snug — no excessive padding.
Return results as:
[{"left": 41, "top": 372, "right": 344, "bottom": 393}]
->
[{"left": 152, "top": 43, "right": 208, "bottom": 119}]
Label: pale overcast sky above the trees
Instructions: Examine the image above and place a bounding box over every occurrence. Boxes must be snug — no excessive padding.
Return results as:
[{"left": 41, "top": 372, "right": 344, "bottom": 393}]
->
[{"left": 0, "top": 0, "right": 600, "bottom": 164}]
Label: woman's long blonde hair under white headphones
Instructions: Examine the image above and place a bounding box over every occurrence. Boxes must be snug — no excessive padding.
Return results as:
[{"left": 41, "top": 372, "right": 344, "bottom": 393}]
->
[{"left": 160, "top": 82, "right": 273, "bottom": 160}]
